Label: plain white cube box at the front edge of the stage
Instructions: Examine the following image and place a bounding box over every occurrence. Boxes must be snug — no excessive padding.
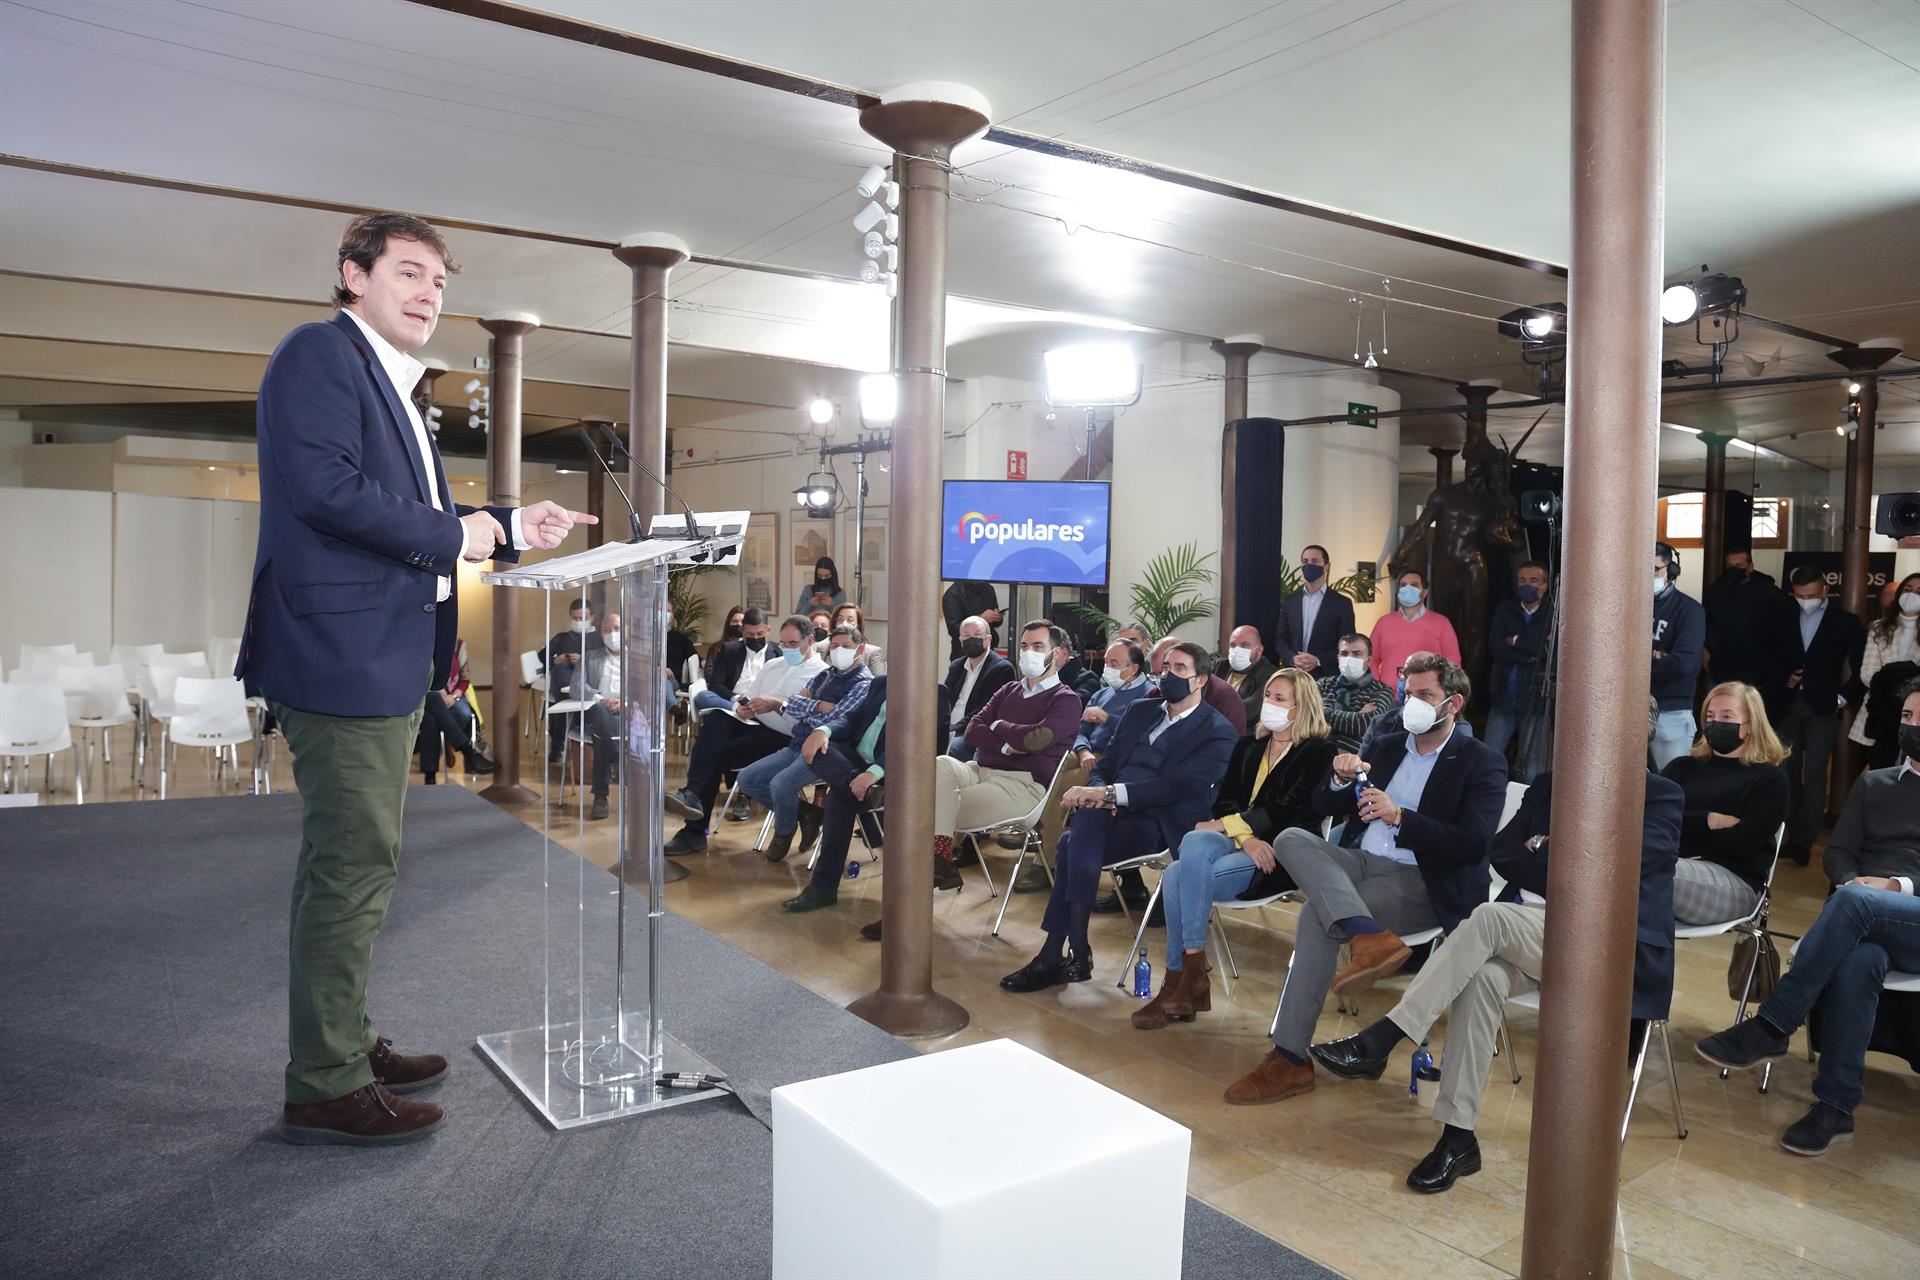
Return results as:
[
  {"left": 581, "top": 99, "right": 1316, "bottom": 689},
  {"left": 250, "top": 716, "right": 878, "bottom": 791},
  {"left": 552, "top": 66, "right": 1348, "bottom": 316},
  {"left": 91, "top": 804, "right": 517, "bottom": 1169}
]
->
[{"left": 774, "top": 1040, "right": 1192, "bottom": 1280}]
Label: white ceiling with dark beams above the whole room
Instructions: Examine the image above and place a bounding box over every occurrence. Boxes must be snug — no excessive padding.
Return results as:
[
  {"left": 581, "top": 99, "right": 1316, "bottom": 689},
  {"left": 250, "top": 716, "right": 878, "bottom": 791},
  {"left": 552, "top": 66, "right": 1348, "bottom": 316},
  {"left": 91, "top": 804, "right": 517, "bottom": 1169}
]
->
[{"left": 0, "top": 0, "right": 1920, "bottom": 468}]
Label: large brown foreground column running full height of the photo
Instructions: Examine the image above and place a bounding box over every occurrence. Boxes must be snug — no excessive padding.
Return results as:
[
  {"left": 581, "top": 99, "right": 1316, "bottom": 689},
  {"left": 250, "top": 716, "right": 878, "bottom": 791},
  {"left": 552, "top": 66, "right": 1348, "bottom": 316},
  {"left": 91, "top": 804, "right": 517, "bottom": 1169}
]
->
[{"left": 1521, "top": 0, "right": 1667, "bottom": 1278}]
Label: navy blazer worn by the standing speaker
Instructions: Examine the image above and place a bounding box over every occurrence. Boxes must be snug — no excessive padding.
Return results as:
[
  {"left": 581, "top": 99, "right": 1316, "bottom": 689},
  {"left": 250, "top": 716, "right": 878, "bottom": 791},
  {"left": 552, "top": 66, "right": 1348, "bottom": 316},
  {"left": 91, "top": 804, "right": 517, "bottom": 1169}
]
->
[{"left": 234, "top": 315, "right": 518, "bottom": 716}]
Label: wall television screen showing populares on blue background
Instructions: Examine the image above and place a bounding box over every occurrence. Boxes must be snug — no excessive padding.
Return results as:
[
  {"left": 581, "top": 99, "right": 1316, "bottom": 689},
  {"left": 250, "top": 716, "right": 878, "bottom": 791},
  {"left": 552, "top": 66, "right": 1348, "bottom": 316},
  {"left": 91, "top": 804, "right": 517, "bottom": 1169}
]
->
[{"left": 941, "top": 480, "right": 1112, "bottom": 587}]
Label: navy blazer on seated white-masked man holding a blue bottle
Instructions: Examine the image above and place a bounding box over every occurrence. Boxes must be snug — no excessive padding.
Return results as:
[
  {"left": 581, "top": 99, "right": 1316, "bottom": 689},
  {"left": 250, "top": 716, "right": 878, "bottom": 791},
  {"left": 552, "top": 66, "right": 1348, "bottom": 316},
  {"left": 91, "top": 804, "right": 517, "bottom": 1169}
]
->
[{"left": 1313, "top": 725, "right": 1507, "bottom": 929}]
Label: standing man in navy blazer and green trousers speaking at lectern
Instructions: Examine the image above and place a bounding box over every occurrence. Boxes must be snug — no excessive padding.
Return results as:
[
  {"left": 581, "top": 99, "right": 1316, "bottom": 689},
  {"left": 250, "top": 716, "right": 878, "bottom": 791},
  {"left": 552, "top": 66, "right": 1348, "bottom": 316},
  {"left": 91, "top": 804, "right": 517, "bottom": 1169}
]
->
[{"left": 234, "top": 213, "right": 593, "bottom": 1146}]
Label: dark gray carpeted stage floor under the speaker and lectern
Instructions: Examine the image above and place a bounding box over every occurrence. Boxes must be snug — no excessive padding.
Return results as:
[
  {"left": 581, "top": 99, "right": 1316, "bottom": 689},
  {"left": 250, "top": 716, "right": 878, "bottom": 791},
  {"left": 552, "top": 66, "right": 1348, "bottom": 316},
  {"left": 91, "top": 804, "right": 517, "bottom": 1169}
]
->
[{"left": 0, "top": 787, "right": 1329, "bottom": 1280}]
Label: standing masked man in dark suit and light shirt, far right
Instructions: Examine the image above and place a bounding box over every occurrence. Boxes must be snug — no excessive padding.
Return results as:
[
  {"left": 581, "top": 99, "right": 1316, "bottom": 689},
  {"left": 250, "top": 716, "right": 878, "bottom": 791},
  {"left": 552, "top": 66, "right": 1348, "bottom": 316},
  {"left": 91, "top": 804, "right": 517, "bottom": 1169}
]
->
[{"left": 1774, "top": 564, "right": 1866, "bottom": 865}]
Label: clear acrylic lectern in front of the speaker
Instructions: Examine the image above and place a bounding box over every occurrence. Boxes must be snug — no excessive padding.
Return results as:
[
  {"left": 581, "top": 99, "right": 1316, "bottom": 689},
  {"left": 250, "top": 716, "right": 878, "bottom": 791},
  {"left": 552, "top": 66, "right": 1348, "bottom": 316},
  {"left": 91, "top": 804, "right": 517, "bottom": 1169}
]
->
[{"left": 480, "top": 526, "right": 739, "bottom": 1128}]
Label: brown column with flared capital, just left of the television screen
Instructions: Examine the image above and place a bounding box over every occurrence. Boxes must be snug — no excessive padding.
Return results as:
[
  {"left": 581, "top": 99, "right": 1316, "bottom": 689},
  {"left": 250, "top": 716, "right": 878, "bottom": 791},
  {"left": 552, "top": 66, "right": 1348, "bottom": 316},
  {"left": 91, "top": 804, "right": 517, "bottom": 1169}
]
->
[{"left": 847, "top": 83, "right": 989, "bottom": 1036}]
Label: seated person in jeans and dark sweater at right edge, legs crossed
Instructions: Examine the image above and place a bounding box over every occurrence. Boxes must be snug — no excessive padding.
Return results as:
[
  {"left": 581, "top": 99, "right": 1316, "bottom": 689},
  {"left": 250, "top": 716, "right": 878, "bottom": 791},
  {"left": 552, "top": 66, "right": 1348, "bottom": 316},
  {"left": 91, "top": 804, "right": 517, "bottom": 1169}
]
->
[{"left": 1697, "top": 681, "right": 1920, "bottom": 1155}]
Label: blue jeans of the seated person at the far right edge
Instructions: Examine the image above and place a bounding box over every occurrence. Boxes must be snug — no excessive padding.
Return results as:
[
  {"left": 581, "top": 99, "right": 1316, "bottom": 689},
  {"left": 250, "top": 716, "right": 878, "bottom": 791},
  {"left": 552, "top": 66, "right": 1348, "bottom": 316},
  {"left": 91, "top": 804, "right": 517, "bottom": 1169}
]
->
[{"left": 1761, "top": 885, "right": 1920, "bottom": 1115}]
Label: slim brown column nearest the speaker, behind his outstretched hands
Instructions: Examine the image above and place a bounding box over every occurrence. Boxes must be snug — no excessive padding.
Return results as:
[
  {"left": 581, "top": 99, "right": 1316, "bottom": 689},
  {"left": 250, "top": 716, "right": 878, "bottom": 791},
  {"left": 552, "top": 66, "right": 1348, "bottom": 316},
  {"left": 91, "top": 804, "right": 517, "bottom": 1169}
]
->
[{"left": 480, "top": 311, "right": 540, "bottom": 804}]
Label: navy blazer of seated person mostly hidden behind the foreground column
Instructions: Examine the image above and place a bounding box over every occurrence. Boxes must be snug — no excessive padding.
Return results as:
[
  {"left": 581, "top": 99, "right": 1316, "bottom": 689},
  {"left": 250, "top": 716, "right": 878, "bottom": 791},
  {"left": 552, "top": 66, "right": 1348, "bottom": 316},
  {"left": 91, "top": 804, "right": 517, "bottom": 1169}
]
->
[{"left": 1494, "top": 773, "right": 1686, "bottom": 1019}]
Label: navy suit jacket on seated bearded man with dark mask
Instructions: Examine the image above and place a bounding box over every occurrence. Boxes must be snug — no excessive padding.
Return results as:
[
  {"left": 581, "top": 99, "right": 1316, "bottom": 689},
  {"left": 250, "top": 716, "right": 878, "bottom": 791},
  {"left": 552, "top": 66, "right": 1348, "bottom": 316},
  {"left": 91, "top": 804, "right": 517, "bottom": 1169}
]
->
[{"left": 1087, "top": 699, "right": 1240, "bottom": 848}]
